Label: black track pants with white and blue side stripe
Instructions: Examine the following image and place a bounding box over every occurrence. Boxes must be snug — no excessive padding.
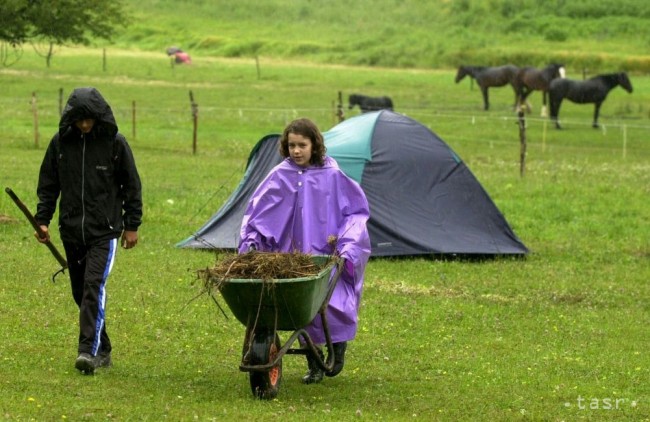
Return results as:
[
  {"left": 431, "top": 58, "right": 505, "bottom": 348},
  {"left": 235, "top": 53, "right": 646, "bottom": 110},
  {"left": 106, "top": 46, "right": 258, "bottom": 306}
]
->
[{"left": 63, "top": 239, "right": 117, "bottom": 356}]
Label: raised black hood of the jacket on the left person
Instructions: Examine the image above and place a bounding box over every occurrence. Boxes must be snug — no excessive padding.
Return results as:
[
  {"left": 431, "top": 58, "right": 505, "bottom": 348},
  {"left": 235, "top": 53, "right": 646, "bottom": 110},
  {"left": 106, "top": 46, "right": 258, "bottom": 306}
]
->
[{"left": 59, "top": 87, "right": 117, "bottom": 138}]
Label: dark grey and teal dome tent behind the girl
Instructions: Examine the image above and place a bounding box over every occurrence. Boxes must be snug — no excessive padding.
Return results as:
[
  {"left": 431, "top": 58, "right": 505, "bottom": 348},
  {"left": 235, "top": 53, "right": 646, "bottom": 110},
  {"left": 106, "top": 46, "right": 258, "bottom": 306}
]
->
[{"left": 177, "top": 110, "right": 528, "bottom": 256}]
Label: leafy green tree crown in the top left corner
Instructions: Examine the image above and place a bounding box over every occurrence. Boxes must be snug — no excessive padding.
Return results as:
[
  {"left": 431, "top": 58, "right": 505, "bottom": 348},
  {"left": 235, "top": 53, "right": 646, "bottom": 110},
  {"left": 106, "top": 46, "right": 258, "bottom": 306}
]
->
[{"left": 0, "top": 0, "right": 128, "bottom": 67}]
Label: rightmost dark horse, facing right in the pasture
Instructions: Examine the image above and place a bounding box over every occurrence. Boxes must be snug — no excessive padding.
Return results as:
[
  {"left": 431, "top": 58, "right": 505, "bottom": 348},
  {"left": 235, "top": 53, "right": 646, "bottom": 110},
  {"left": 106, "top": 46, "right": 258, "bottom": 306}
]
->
[{"left": 548, "top": 72, "right": 632, "bottom": 129}]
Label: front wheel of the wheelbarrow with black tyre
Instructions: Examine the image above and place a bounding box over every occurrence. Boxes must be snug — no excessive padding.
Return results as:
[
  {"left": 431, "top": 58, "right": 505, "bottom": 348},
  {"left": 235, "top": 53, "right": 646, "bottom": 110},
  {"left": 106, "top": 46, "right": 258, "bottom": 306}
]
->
[{"left": 249, "top": 330, "right": 282, "bottom": 400}]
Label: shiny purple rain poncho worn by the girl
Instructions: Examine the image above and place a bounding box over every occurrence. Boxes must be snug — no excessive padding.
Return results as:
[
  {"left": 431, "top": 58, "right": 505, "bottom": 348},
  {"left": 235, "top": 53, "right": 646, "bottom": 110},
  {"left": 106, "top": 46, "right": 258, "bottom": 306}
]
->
[{"left": 239, "top": 156, "right": 370, "bottom": 344}]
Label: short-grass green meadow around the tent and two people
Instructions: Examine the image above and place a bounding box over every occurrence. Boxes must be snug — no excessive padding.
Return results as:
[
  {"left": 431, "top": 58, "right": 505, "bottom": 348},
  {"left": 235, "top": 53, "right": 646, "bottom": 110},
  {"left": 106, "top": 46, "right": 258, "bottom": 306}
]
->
[{"left": 0, "top": 44, "right": 650, "bottom": 421}]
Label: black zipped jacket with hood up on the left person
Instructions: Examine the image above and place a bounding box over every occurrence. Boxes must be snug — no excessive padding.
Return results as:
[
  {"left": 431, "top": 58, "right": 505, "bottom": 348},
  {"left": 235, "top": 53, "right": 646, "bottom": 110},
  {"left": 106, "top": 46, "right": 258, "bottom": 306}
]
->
[{"left": 35, "top": 88, "right": 142, "bottom": 244}]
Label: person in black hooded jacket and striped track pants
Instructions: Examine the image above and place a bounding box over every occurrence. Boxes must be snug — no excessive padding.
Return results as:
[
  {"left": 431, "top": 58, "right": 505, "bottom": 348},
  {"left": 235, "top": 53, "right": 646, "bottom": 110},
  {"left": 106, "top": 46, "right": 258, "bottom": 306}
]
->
[{"left": 35, "top": 88, "right": 142, "bottom": 374}]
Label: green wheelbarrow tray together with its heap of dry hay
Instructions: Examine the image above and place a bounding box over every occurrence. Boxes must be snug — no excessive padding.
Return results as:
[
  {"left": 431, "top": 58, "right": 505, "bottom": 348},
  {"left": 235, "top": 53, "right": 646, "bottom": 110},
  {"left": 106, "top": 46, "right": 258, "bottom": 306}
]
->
[{"left": 198, "top": 251, "right": 337, "bottom": 330}]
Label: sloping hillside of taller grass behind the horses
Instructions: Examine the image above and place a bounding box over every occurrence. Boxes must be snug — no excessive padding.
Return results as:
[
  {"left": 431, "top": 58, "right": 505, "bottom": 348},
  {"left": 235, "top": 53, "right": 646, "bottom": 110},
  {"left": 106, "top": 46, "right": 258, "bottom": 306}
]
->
[{"left": 115, "top": 0, "right": 650, "bottom": 73}]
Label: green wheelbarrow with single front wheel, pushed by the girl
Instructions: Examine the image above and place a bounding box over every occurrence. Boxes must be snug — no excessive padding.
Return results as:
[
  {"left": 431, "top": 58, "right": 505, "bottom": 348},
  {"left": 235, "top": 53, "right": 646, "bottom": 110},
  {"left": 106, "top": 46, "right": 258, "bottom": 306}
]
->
[{"left": 219, "top": 255, "right": 343, "bottom": 400}]
